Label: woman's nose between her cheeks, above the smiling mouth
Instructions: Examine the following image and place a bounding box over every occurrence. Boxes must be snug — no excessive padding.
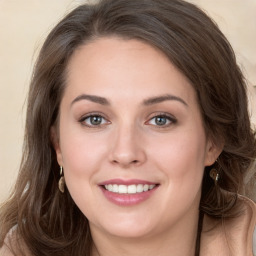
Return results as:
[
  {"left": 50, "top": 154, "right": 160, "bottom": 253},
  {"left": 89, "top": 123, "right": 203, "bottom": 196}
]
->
[{"left": 110, "top": 125, "right": 146, "bottom": 168}]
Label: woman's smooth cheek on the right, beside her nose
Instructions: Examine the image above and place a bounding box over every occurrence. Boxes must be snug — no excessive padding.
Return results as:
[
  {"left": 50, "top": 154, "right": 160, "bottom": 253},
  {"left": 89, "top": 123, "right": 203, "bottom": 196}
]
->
[{"left": 151, "top": 129, "right": 206, "bottom": 189}]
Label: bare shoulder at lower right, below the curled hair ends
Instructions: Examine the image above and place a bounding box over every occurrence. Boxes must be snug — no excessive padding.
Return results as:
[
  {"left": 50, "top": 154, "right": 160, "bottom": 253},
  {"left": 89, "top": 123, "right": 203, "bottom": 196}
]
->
[{"left": 202, "top": 196, "right": 256, "bottom": 256}]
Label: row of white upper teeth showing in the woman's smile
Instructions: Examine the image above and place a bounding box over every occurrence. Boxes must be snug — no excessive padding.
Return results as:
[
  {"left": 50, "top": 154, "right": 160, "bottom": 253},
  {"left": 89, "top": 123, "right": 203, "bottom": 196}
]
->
[{"left": 105, "top": 184, "right": 156, "bottom": 194}]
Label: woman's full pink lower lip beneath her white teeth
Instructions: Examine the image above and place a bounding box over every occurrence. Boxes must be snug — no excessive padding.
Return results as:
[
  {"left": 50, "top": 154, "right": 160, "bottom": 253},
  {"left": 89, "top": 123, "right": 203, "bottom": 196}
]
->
[{"left": 100, "top": 186, "right": 158, "bottom": 206}]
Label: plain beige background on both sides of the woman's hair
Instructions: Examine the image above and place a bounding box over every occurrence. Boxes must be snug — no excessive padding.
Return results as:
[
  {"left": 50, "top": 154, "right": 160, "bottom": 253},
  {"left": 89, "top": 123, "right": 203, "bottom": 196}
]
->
[{"left": 0, "top": 0, "right": 256, "bottom": 202}]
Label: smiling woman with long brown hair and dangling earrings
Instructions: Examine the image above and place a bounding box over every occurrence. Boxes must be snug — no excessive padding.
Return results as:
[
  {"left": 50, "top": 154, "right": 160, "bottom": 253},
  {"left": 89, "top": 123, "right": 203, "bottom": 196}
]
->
[{"left": 0, "top": 0, "right": 256, "bottom": 256}]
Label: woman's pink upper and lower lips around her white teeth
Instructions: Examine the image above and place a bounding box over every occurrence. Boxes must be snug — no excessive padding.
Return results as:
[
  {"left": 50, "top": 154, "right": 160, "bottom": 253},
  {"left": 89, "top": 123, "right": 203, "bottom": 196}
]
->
[{"left": 99, "top": 179, "right": 159, "bottom": 206}]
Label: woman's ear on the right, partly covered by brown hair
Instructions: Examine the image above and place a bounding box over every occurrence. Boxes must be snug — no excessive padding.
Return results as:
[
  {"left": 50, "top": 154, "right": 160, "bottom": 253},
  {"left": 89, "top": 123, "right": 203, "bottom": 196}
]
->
[{"left": 204, "top": 139, "right": 224, "bottom": 166}]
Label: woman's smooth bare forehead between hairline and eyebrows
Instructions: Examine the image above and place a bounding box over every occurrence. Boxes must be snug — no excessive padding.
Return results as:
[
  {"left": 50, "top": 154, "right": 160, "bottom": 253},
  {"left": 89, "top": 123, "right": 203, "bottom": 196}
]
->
[{"left": 66, "top": 37, "right": 194, "bottom": 106}]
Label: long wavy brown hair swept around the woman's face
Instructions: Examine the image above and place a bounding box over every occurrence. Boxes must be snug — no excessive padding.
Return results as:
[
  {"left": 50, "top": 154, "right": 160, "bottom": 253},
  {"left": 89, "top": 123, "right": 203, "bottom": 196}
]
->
[{"left": 0, "top": 0, "right": 256, "bottom": 256}]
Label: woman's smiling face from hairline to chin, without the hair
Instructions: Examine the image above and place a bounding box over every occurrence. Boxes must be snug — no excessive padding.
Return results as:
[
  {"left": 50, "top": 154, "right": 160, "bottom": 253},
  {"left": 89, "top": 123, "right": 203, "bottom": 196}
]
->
[{"left": 55, "top": 38, "right": 218, "bottom": 240}]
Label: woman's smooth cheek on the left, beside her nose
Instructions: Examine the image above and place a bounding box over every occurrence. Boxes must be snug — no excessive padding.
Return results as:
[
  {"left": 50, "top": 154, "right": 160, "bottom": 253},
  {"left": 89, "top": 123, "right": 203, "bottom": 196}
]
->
[{"left": 60, "top": 125, "right": 107, "bottom": 195}]
